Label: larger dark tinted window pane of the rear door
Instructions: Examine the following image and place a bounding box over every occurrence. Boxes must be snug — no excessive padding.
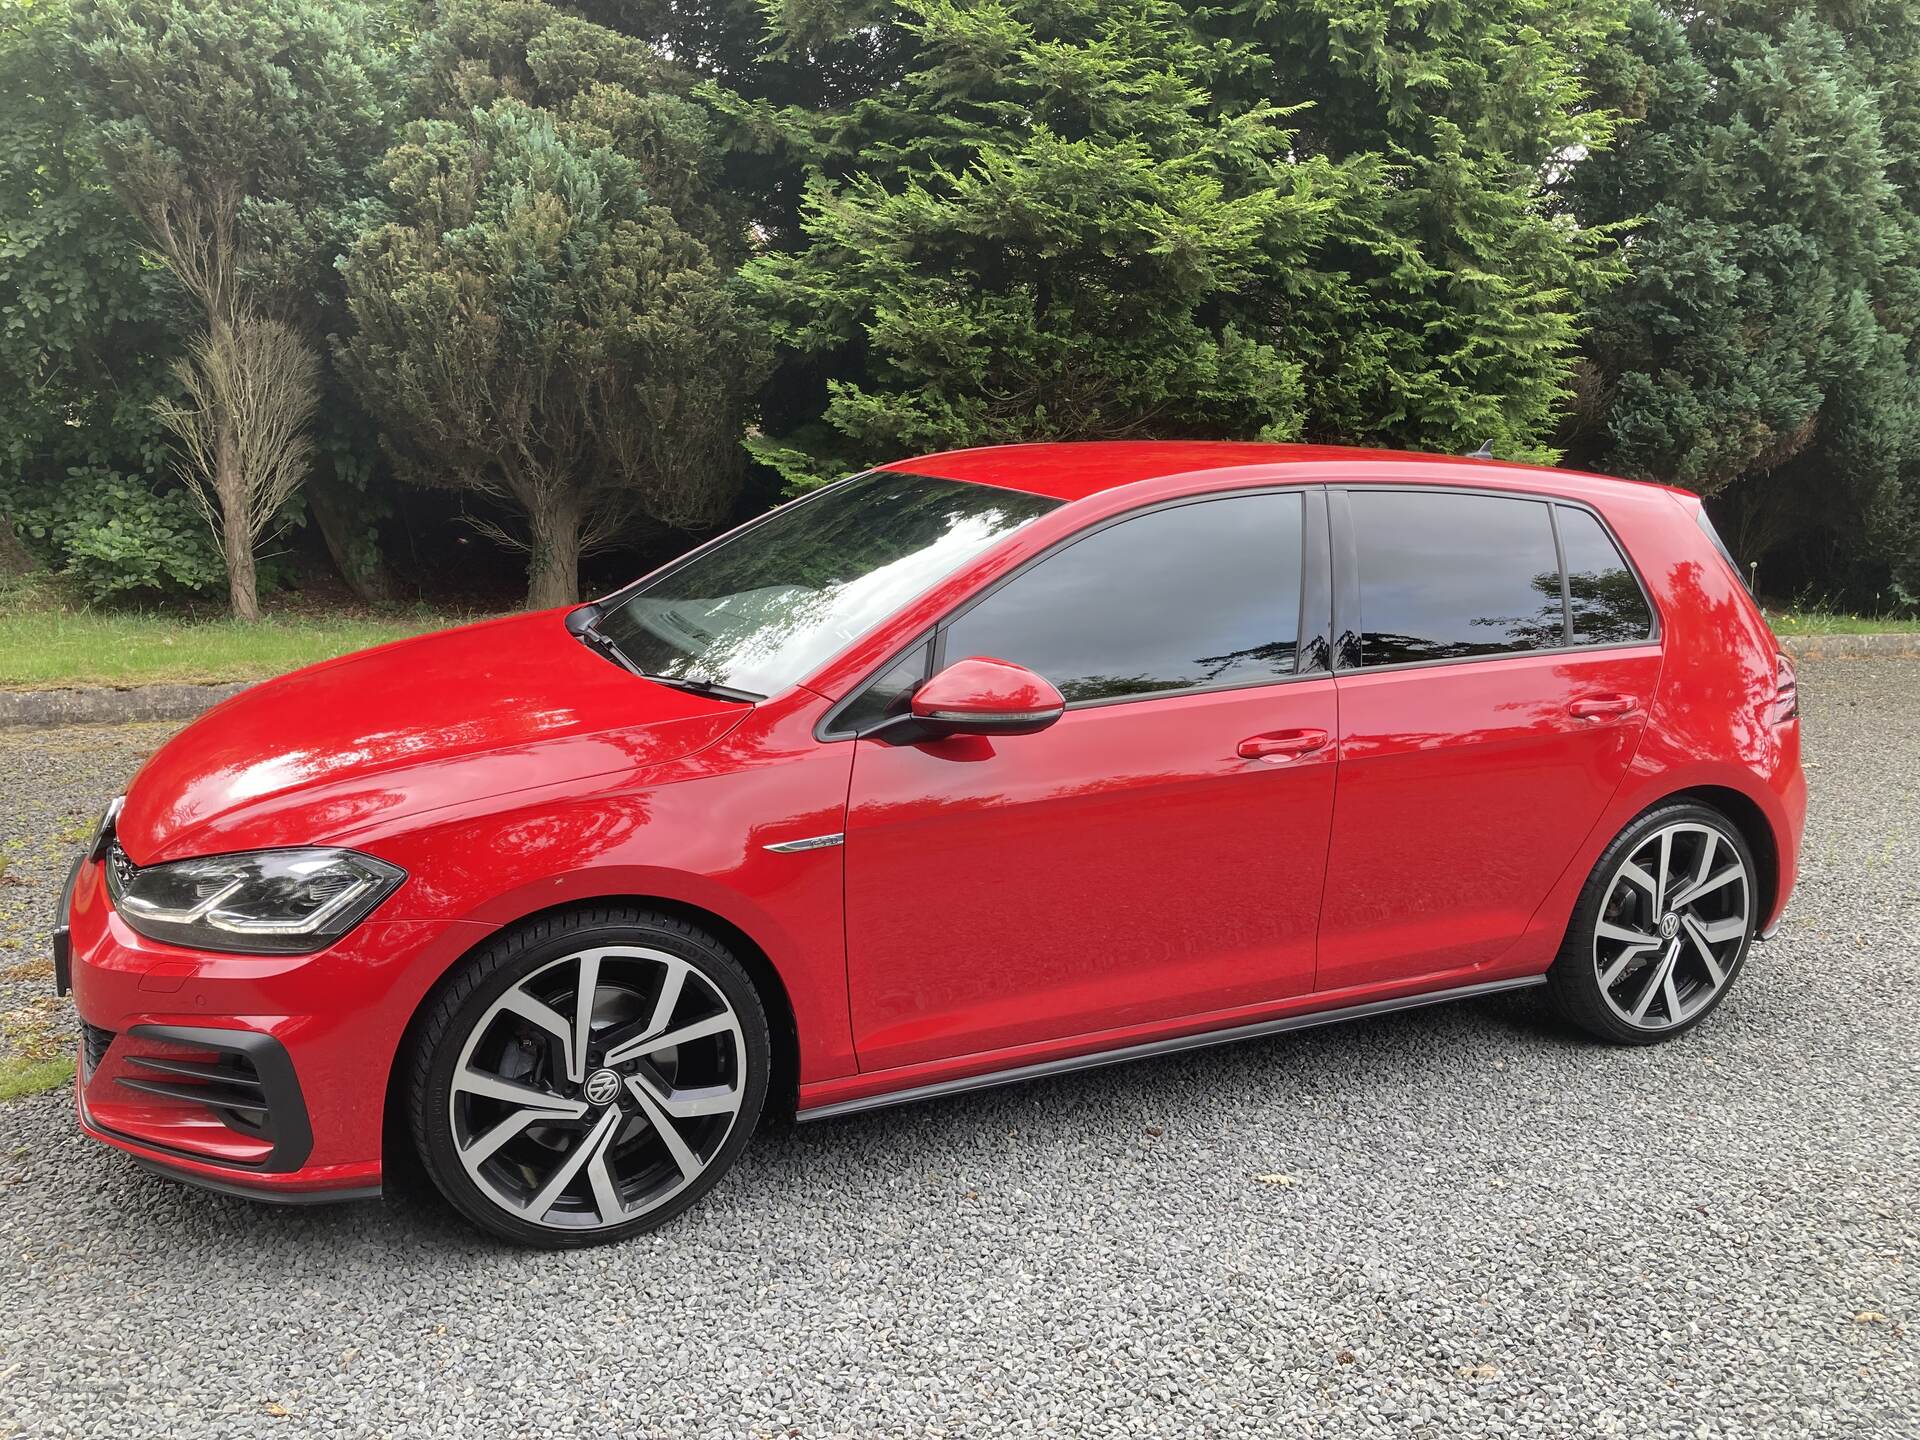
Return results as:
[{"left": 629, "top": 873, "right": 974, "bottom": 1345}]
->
[{"left": 1348, "top": 490, "right": 1567, "bottom": 666}]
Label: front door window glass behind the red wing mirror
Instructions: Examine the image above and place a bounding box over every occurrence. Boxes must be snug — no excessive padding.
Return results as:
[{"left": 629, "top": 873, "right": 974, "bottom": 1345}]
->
[{"left": 943, "top": 493, "right": 1302, "bottom": 701}]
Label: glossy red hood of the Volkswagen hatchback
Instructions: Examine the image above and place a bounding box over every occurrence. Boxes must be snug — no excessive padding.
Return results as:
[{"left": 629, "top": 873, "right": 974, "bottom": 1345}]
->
[{"left": 117, "top": 611, "right": 749, "bottom": 864}]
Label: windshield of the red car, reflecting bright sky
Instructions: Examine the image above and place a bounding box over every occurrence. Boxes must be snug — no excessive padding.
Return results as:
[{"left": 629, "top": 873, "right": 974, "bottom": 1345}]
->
[{"left": 597, "top": 470, "right": 1060, "bottom": 695}]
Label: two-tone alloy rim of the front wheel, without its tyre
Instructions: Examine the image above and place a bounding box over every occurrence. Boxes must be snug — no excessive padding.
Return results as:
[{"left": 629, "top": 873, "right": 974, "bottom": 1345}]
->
[{"left": 447, "top": 945, "right": 747, "bottom": 1231}]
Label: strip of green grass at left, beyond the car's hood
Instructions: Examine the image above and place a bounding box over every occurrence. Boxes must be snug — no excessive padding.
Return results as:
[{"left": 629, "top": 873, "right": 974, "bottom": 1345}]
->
[{"left": 0, "top": 595, "right": 468, "bottom": 689}]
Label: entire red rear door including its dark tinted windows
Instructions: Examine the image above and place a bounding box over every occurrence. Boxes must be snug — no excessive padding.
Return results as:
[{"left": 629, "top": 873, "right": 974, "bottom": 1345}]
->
[{"left": 1315, "top": 486, "right": 1661, "bottom": 991}]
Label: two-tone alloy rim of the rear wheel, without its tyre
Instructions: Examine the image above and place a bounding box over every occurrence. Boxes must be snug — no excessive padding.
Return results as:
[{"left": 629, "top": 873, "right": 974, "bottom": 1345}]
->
[{"left": 1594, "top": 820, "right": 1753, "bottom": 1031}]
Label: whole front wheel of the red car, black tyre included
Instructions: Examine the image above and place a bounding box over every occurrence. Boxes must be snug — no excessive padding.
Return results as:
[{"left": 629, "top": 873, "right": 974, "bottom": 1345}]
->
[{"left": 407, "top": 906, "right": 772, "bottom": 1248}]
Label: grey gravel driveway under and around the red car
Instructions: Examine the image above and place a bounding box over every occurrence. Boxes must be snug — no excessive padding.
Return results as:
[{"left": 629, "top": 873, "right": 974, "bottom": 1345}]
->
[{"left": 0, "top": 662, "right": 1920, "bottom": 1440}]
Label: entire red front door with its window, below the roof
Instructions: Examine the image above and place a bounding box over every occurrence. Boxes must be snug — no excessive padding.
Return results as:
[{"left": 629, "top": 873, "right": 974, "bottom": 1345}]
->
[{"left": 845, "top": 490, "right": 1336, "bottom": 1069}]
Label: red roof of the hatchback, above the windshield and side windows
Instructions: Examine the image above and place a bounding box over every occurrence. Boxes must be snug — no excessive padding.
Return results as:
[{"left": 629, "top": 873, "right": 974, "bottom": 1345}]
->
[{"left": 879, "top": 440, "right": 1668, "bottom": 501}]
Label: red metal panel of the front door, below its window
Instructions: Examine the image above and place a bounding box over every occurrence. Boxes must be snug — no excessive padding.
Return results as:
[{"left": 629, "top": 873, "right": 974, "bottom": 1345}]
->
[{"left": 847, "top": 680, "right": 1334, "bottom": 1068}]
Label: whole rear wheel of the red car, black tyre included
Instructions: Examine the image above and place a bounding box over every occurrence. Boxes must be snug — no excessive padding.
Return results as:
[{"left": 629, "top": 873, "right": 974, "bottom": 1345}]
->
[{"left": 1548, "top": 803, "right": 1759, "bottom": 1044}]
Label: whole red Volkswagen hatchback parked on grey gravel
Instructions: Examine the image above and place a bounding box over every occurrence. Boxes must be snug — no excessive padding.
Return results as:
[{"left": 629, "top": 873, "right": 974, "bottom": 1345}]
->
[{"left": 56, "top": 444, "right": 1805, "bottom": 1244}]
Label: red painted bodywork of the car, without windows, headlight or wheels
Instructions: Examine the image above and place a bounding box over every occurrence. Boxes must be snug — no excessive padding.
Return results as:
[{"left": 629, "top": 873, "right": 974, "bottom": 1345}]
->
[{"left": 69, "top": 442, "right": 1807, "bottom": 1190}]
